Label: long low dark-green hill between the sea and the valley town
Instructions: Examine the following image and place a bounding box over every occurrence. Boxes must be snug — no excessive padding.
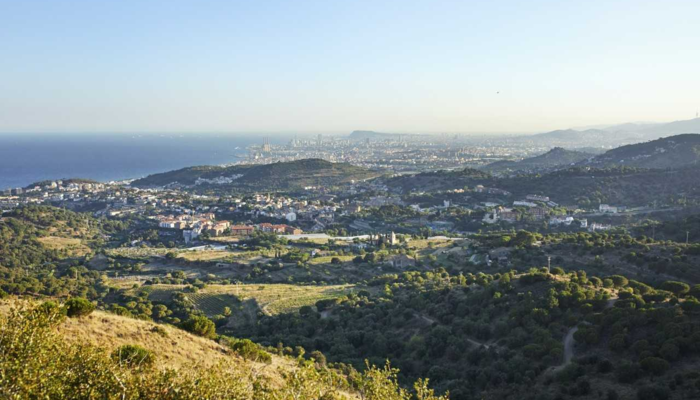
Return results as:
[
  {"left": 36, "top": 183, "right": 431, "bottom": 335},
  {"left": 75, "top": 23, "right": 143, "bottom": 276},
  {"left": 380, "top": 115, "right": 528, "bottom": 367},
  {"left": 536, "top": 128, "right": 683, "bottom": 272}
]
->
[{"left": 131, "top": 159, "right": 378, "bottom": 191}]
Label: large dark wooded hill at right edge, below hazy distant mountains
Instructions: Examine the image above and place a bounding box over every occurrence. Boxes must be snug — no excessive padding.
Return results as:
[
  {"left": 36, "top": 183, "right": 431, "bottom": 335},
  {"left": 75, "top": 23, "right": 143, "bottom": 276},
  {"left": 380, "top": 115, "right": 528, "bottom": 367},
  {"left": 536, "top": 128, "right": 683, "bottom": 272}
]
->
[{"left": 582, "top": 134, "right": 700, "bottom": 169}]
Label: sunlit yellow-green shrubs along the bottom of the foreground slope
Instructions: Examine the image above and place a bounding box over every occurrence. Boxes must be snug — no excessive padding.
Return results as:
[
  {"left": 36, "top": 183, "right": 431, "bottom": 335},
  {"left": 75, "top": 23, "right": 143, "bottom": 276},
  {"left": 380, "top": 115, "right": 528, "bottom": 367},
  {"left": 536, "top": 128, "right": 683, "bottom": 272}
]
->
[{"left": 0, "top": 303, "right": 441, "bottom": 400}]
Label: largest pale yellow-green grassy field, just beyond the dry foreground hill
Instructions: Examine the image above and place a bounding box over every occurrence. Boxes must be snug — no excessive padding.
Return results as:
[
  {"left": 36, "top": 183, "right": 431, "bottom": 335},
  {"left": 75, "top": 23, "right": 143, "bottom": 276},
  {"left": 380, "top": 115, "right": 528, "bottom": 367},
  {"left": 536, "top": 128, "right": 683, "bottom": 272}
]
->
[{"left": 138, "top": 284, "right": 354, "bottom": 316}]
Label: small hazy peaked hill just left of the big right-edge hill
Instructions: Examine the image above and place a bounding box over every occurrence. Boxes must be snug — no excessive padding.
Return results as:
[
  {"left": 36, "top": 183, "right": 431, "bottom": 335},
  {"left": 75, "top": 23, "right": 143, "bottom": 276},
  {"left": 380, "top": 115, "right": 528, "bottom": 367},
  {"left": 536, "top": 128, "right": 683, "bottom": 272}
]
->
[{"left": 483, "top": 147, "right": 593, "bottom": 173}]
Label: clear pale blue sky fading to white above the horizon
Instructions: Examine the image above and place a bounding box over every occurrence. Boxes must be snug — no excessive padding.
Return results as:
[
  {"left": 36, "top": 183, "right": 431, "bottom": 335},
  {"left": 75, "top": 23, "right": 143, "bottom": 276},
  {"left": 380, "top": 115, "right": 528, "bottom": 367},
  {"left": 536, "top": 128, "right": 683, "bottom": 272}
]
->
[{"left": 0, "top": 0, "right": 700, "bottom": 134}]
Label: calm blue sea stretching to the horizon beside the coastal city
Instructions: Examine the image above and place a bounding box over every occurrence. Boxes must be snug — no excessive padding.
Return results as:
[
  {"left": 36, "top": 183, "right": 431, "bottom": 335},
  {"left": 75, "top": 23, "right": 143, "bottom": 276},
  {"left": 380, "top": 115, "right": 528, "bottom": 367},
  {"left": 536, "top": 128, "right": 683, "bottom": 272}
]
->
[{"left": 0, "top": 133, "right": 289, "bottom": 189}]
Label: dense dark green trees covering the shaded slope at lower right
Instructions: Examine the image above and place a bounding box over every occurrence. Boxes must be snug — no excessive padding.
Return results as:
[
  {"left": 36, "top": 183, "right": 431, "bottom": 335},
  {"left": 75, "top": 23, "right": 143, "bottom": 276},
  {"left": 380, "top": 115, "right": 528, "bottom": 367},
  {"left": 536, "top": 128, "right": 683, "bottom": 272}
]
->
[{"left": 226, "top": 268, "right": 700, "bottom": 399}]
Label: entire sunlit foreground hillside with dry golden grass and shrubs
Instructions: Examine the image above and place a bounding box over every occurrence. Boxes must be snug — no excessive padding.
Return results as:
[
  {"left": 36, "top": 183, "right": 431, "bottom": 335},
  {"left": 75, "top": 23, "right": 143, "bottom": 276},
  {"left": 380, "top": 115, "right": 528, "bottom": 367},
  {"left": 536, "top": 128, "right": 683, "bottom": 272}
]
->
[{"left": 0, "top": 298, "right": 446, "bottom": 400}]
